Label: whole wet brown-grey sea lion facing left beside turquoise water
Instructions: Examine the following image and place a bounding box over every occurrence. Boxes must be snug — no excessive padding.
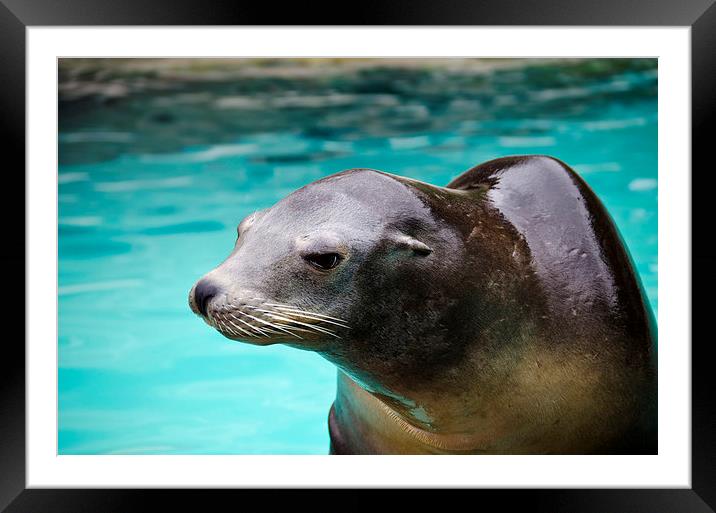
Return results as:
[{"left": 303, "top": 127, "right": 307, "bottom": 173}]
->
[{"left": 189, "top": 156, "right": 657, "bottom": 454}]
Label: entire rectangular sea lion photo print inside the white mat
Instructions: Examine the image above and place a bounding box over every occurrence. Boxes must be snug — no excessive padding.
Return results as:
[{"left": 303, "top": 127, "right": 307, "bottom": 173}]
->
[{"left": 57, "top": 58, "right": 658, "bottom": 455}]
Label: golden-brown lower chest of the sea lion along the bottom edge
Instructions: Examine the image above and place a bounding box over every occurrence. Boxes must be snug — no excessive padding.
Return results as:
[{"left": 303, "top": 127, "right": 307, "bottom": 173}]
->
[{"left": 329, "top": 340, "right": 656, "bottom": 454}]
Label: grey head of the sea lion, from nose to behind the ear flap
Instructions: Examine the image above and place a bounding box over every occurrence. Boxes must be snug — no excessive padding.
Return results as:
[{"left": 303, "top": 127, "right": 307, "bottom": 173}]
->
[{"left": 189, "top": 169, "right": 470, "bottom": 388}]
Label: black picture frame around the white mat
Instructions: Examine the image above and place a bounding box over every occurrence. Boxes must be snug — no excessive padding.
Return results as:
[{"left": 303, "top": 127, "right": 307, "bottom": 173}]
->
[{"left": 0, "top": 0, "right": 716, "bottom": 513}]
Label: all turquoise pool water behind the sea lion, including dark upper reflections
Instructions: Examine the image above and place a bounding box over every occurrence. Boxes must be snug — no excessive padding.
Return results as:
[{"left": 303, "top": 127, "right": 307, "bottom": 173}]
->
[{"left": 58, "top": 60, "right": 657, "bottom": 454}]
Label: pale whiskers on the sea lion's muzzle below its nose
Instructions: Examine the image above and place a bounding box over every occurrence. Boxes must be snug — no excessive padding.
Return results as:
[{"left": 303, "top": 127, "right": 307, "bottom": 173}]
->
[{"left": 209, "top": 303, "right": 350, "bottom": 340}]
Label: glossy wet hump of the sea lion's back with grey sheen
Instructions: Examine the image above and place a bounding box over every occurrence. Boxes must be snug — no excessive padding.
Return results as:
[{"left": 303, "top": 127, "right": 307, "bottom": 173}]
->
[{"left": 447, "top": 155, "right": 655, "bottom": 353}]
